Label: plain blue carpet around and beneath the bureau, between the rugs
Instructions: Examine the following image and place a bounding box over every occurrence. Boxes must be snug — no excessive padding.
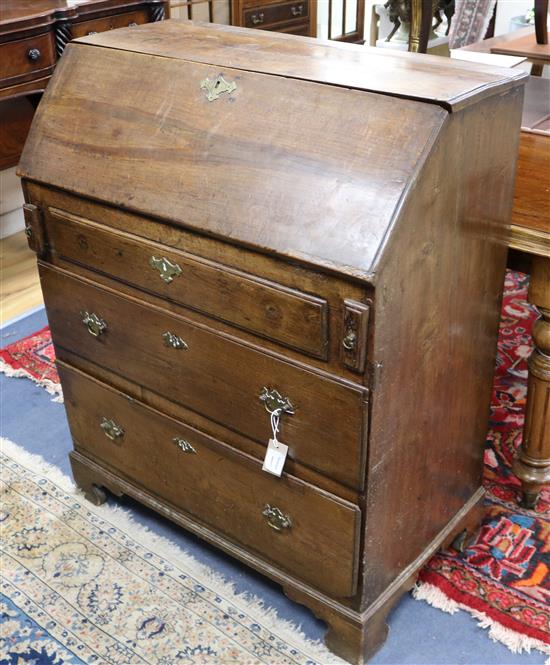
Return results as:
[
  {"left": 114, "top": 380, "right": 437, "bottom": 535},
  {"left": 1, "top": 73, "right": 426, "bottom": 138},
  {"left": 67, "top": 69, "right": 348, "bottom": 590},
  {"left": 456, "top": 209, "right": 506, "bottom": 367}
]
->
[{"left": 0, "top": 310, "right": 544, "bottom": 665}]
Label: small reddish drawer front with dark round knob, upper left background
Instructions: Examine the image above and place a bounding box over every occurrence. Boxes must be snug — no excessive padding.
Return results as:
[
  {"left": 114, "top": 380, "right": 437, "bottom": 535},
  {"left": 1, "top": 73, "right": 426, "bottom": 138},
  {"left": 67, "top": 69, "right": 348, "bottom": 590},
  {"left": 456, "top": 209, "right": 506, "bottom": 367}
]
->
[{"left": 0, "top": 33, "right": 55, "bottom": 84}]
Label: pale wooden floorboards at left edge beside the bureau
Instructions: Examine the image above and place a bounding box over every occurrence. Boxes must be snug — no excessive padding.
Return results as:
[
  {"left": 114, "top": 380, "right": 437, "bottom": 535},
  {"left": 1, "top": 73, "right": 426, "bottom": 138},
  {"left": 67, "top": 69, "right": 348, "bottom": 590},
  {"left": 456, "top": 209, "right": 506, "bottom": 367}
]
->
[{"left": 0, "top": 231, "right": 43, "bottom": 325}]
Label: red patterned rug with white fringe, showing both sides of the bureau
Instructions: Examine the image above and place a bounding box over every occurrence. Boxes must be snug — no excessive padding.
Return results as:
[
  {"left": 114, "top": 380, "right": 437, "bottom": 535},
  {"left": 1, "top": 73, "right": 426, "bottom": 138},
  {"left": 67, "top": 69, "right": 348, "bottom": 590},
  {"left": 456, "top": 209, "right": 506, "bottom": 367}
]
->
[{"left": 0, "top": 272, "right": 550, "bottom": 654}]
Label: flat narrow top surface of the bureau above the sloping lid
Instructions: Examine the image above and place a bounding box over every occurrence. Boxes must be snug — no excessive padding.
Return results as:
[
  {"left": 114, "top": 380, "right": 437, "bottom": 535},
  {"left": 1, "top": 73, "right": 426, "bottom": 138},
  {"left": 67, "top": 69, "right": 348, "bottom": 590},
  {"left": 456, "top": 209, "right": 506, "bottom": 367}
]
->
[{"left": 75, "top": 19, "right": 527, "bottom": 111}]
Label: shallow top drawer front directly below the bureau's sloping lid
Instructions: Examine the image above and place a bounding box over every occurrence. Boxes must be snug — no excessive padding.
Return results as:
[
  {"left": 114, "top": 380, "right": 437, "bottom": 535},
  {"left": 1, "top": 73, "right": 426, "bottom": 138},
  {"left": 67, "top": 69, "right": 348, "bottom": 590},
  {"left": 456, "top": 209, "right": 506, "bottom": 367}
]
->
[{"left": 48, "top": 209, "right": 328, "bottom": 359}]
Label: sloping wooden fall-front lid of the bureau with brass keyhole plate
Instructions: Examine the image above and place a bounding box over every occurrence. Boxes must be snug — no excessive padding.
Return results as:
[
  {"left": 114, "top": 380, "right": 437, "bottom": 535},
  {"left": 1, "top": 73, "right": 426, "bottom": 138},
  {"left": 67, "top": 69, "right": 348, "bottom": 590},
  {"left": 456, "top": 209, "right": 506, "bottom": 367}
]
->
[{"left": 20, "top": 41, "right": 446, "bottom": 275}]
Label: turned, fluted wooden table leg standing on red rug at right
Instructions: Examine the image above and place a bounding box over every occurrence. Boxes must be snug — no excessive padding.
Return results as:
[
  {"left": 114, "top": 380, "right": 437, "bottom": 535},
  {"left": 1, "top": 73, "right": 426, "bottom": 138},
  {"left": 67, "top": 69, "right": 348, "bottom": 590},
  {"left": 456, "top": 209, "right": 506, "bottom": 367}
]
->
[{"left": 513, "top": 256, "right": 550, "bottom": 508}]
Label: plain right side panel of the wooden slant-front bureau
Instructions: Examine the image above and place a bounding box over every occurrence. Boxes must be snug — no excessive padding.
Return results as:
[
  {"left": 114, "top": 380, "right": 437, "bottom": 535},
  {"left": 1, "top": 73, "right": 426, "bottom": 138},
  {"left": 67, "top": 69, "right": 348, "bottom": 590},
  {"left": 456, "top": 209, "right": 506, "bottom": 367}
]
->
[{"left": 364, "top": 89, "right": 522, "bottom": 604}]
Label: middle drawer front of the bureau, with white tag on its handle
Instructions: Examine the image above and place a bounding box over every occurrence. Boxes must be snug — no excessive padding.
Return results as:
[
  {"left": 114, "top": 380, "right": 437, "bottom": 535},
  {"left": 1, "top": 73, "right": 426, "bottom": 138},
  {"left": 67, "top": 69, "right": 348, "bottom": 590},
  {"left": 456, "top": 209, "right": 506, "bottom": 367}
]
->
[{"left": 40, "top": 265, "right": 366, "bottom": 487}]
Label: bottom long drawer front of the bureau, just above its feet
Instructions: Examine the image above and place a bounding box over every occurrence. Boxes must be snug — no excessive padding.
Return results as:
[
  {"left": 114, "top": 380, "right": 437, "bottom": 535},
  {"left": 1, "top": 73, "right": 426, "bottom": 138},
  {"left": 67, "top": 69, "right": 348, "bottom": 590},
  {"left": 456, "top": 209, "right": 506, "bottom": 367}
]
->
[{"left": 59, "top": 363, "right": 360, "bottom": 596}]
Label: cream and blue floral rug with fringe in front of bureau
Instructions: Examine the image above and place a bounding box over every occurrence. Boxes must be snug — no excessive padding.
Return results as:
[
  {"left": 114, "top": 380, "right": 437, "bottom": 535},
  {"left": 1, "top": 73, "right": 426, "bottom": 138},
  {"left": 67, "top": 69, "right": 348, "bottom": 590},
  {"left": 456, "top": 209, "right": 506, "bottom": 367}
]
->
[{"left": 0, "top": 439, "right": 345, "bottom": 665}]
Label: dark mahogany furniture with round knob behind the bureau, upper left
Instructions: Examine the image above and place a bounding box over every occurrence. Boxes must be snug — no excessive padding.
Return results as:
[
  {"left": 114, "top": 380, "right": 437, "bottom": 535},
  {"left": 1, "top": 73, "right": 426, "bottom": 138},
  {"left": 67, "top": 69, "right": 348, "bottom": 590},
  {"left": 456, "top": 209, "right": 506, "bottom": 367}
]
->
[{"left": 0, "top": 0, "right": 169, "bottom": 170}]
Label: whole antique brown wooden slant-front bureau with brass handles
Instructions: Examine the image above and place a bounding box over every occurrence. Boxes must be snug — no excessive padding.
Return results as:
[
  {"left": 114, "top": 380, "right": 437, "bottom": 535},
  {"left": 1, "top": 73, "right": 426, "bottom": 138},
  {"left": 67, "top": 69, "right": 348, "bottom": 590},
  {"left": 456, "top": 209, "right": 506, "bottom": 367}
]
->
[{"left": 20, "top": 21, "right": 524, "bottom": 663}]
